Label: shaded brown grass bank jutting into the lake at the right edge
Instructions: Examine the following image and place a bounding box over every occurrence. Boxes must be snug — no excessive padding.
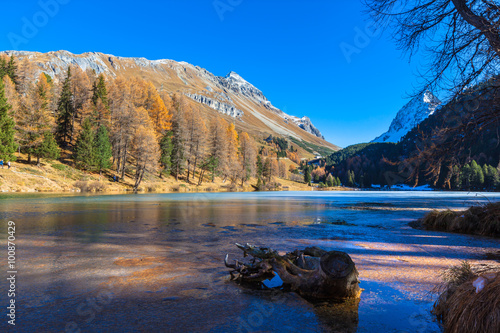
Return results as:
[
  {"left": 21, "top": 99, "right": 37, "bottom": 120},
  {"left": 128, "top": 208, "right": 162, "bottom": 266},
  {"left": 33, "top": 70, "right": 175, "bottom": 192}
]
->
[{"left": 417, "top": 202, "right": 500, "bottom": 237}]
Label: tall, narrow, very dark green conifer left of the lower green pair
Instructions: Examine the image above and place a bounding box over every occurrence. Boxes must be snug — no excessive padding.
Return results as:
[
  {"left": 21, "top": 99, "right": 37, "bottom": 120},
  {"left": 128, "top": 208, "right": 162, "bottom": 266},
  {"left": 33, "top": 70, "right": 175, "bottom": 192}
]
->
[{"left": 56, "top": 67, "right": 75, "bottom": 146}]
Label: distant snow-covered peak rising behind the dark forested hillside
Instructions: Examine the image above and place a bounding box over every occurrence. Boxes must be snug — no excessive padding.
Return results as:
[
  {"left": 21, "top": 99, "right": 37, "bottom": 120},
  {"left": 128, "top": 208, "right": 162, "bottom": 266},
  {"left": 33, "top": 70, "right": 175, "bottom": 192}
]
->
[{"left": 372, "top": 91, "right": 441, "bottom": 143}]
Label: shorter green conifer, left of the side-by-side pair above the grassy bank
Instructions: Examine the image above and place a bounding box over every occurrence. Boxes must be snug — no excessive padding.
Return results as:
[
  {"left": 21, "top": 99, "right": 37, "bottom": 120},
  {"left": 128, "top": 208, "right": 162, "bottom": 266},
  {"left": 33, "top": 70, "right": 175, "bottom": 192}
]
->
[{"left": 73, "top": 118, "right": 96, "bottom": 170}]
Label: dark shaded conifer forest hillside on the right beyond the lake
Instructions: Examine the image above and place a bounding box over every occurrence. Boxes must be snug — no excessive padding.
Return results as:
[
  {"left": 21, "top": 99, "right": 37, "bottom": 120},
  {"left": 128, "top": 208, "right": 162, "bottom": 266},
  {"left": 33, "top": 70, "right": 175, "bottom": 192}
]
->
[{"left": 324, "top": 78, "right": 500, "bottom": 191}]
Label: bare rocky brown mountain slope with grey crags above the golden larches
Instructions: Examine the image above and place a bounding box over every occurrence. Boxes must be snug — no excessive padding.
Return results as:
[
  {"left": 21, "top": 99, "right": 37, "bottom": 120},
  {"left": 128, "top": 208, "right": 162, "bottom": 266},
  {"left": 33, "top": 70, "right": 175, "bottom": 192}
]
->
[{"left": 2, "top": 51, "right": 339, "bottom": 150}]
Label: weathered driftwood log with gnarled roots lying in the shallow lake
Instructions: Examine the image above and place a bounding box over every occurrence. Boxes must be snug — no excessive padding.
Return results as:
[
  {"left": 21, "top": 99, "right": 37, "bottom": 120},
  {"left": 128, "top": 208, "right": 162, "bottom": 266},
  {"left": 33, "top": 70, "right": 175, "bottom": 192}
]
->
[{"left": 225, "top": 244, "right": 361, "bottom": 300}]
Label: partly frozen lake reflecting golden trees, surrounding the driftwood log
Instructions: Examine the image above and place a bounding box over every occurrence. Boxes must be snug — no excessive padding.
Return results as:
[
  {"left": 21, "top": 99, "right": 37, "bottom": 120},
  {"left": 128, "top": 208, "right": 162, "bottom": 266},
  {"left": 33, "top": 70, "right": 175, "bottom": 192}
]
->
[{"left": 0, "top": 192, "right": 500, "bottom": 332}]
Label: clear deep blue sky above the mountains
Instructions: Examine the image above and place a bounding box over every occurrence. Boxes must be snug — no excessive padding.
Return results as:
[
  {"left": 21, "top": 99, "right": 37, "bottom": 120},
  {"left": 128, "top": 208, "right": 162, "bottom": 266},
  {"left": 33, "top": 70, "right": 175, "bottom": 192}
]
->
[{"left": 0, "top": 0, "right": 428, "bottom": 147}]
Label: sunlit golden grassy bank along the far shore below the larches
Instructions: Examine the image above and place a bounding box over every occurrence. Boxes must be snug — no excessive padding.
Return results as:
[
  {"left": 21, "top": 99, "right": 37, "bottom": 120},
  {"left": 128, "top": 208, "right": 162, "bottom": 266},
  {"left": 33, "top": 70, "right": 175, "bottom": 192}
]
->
[{"left": 0, "top": 162, "right": 355, "bottom": 193}]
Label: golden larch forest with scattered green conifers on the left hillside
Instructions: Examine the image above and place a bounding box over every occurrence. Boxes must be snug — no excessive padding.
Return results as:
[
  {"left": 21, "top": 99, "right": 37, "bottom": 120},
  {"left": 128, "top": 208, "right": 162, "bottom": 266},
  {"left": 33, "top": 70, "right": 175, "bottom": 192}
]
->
[{"left": 0, "top": 56, "right": 300, "bottom": 190}]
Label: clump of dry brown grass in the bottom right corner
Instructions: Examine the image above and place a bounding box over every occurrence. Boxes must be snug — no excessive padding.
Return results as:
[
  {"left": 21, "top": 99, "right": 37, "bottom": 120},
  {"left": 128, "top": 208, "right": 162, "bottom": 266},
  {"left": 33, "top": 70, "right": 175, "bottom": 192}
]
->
[{"left": 432, "top": 262, "right": 500, "bottom": 333}]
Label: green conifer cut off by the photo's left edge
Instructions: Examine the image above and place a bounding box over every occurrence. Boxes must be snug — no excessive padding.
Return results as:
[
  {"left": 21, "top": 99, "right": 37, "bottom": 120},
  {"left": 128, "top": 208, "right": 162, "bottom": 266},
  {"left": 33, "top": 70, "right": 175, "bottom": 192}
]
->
[{"left": 0, "top": 79, "right": 17, "bottom": 161}]
